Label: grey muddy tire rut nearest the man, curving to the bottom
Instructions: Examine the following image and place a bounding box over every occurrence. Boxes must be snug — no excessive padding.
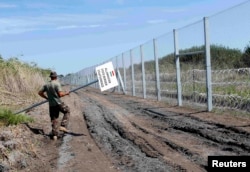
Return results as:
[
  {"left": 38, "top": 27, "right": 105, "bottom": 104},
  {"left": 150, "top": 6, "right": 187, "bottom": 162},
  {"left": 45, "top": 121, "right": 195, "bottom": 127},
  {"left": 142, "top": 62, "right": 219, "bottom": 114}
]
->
[{"left": 79, "top": 93, "right": 175, "bottom": 171}]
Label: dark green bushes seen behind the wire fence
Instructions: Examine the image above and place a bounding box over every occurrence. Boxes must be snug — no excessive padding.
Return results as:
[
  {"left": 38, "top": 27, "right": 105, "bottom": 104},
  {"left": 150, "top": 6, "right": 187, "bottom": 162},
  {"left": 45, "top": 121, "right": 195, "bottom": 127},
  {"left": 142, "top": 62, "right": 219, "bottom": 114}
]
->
[{"left": 131, "top": 43, "right": 250, "bottom": 73}]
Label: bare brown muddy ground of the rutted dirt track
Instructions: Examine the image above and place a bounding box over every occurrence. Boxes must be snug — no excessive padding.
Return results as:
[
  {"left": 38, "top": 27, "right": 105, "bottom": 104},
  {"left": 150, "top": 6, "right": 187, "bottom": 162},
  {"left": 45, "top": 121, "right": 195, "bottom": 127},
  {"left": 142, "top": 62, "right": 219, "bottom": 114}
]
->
[{"left": 0, "top": 88, "right": 250, "bottom": 172}]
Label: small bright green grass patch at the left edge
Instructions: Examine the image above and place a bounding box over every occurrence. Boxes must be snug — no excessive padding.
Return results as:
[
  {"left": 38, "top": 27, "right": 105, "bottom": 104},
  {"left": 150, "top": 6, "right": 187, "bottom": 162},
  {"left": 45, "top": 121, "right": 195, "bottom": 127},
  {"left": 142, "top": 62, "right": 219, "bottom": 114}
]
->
[{"left": 0, "top": 109, "right": 34, "bottom": 126}]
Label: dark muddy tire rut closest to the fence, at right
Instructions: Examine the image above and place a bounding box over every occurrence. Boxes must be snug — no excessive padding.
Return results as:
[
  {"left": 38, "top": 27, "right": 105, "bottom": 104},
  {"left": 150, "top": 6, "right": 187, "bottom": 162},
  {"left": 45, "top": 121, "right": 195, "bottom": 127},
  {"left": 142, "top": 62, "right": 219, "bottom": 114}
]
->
[{"left": 142, "top": 109, "right": 250, "bottom": 155}]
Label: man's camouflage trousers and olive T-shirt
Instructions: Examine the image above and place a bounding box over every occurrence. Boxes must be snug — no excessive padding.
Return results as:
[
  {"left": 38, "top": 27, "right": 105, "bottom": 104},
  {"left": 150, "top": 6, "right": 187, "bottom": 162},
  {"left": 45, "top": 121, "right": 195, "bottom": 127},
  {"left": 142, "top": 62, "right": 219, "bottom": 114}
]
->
[{"left": 40, "top": 80, "right": 70, "bottom": 136}]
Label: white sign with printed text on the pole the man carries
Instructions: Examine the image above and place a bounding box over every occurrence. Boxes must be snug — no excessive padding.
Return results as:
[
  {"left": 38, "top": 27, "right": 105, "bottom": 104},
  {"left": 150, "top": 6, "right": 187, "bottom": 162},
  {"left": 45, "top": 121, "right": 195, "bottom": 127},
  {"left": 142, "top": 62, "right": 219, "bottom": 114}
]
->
[{"left": 95, "top": 62, "right": 118, "bottom": 91}]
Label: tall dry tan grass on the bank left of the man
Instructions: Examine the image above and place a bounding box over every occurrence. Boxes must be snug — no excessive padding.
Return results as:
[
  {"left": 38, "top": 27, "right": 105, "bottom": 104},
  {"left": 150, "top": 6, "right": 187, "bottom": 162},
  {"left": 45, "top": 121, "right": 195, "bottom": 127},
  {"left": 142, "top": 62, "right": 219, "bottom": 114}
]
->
[{"left": 0, "top": 56, "right": 50, "bottom": 109}]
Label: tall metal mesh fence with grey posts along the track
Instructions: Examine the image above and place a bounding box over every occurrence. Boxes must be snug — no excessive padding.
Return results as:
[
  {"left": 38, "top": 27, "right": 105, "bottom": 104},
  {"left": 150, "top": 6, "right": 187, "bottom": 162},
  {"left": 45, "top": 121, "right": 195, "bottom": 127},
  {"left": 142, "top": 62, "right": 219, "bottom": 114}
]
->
[{"left": 62, "top": 1, "right": 250, "bottom": 111}]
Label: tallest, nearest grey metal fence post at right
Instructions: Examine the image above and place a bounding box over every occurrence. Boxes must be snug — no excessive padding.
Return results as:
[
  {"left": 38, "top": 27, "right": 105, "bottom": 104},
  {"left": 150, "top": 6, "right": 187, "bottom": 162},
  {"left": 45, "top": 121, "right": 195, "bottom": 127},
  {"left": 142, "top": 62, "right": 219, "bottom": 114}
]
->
[{"left": 204, "top": 17, "right": 213, "bottom": 112}]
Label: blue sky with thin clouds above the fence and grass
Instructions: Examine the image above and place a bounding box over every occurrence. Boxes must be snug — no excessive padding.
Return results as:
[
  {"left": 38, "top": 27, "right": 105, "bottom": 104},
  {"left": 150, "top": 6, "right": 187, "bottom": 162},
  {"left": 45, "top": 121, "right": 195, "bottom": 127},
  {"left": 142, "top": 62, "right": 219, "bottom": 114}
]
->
[{"left": 0, "top": 0, "right": 249, "bottom": 75}]
